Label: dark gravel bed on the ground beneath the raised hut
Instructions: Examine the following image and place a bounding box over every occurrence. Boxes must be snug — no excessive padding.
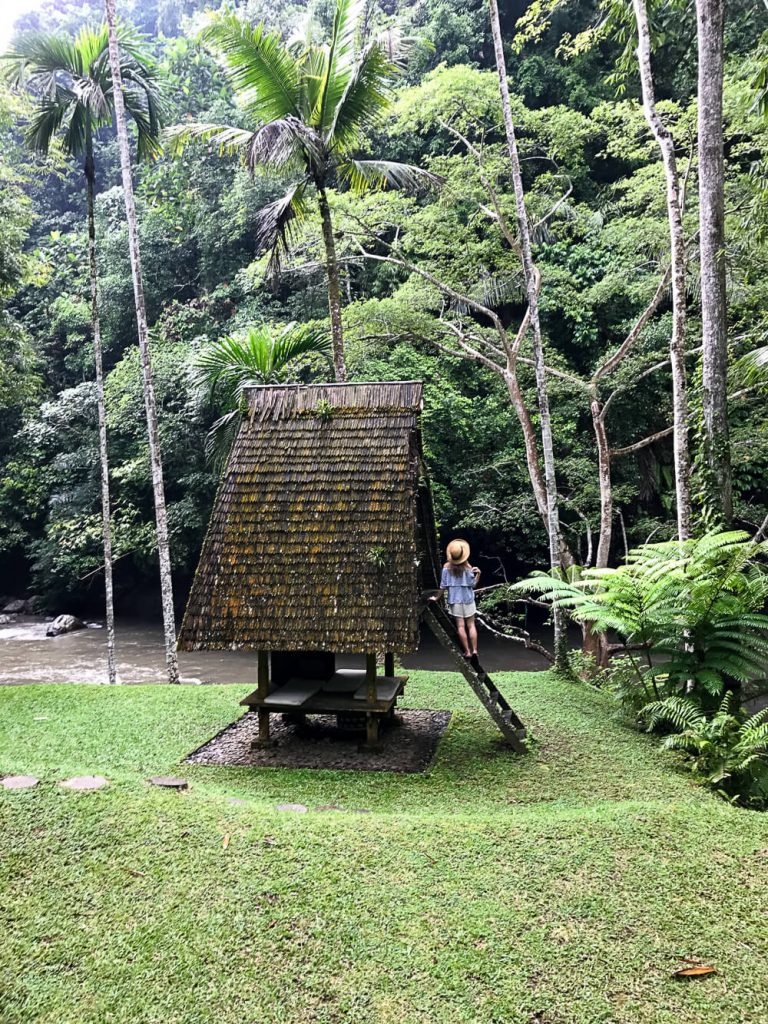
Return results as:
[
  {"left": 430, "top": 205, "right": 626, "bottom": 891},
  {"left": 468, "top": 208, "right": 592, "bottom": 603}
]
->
[{"left": 186, "top": 711, "right": 451, "bottom": 772}]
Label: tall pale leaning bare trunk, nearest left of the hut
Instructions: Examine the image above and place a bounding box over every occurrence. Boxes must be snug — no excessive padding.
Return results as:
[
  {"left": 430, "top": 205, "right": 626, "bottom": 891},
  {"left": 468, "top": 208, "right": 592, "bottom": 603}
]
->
[{"left": 104, "top": 0, "right": 179, "bottom": 683}]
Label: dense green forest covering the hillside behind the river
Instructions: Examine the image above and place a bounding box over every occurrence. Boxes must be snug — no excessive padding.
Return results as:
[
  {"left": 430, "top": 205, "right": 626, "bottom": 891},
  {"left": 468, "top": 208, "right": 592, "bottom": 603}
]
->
[{"left": 0, "top": 0, "right": 768, "bottom": 612}]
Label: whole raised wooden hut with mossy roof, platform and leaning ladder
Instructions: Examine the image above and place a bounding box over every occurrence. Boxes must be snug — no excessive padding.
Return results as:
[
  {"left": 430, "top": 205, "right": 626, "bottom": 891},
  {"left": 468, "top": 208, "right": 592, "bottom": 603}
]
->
[{"left": 178, "top": 381, "right": 525, "bottom": 753}]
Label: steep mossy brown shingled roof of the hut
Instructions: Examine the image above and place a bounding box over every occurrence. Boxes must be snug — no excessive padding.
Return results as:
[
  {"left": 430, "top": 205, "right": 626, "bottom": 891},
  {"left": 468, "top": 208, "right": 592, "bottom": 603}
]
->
[{"left": 179, "top": 382, "right": 428, "bottom": 653}]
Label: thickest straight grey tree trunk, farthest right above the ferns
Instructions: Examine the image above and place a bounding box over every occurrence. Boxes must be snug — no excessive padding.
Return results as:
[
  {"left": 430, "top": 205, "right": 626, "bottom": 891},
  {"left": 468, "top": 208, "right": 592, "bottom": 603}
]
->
[{"left": 696, "top": 0, "right": 733, "bottom": 525}]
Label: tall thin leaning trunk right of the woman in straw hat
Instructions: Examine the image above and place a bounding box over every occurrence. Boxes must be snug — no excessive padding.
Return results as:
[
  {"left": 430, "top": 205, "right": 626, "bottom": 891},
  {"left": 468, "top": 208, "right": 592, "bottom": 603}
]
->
[{"left": 488, "top": 0, "right": 565, "bottom": 666}]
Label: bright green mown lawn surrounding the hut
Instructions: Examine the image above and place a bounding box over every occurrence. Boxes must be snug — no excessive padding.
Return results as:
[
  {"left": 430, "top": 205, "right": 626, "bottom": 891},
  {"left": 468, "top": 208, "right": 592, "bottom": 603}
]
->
[{"left": 0, "top": 673, "right": 768, "bottom": 1024}]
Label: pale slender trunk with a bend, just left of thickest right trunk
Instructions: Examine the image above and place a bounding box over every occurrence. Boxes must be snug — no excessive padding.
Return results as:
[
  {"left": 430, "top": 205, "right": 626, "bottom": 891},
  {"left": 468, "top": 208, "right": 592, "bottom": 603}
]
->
[{"left": 632, "top": 0, "right": 691, "bottom": 541}]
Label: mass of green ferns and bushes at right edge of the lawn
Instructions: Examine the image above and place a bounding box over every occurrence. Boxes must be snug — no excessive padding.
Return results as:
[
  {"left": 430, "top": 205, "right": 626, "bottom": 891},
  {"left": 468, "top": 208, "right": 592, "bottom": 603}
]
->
[{"left": 512, "top": 532, "right": 768, "bottom": 807}]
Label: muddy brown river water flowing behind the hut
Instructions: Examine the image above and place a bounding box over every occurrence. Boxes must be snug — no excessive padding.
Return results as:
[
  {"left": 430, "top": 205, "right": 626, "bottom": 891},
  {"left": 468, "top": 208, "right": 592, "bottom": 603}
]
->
[{"left": 0, "top": 616, "right": 550, "bottom": 685}]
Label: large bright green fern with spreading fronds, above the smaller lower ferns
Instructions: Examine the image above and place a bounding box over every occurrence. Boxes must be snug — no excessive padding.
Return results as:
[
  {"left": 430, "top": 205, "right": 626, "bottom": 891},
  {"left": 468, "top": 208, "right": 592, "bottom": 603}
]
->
[{"left": 512, "top": 530, "right": 768, "bottom": 715}]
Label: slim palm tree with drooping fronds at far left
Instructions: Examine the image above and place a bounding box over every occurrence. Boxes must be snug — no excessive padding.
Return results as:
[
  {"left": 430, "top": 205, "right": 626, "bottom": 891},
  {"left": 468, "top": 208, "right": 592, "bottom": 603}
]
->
[{"left": 4, "top": 26, "right": 160, "bottom": 683}]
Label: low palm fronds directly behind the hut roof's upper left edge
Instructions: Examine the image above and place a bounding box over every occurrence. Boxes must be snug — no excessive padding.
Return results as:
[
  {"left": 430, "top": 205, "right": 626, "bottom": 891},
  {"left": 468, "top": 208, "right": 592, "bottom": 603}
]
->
[{"left": 193, "top": 324, "right": 331, "bottom": 467}]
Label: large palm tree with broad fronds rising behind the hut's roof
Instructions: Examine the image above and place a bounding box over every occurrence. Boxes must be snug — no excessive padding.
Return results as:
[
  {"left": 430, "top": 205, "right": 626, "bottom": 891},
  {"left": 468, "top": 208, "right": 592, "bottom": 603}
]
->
[{"left": 167, "top": 0, "right": 439, "bottom": 381}]
